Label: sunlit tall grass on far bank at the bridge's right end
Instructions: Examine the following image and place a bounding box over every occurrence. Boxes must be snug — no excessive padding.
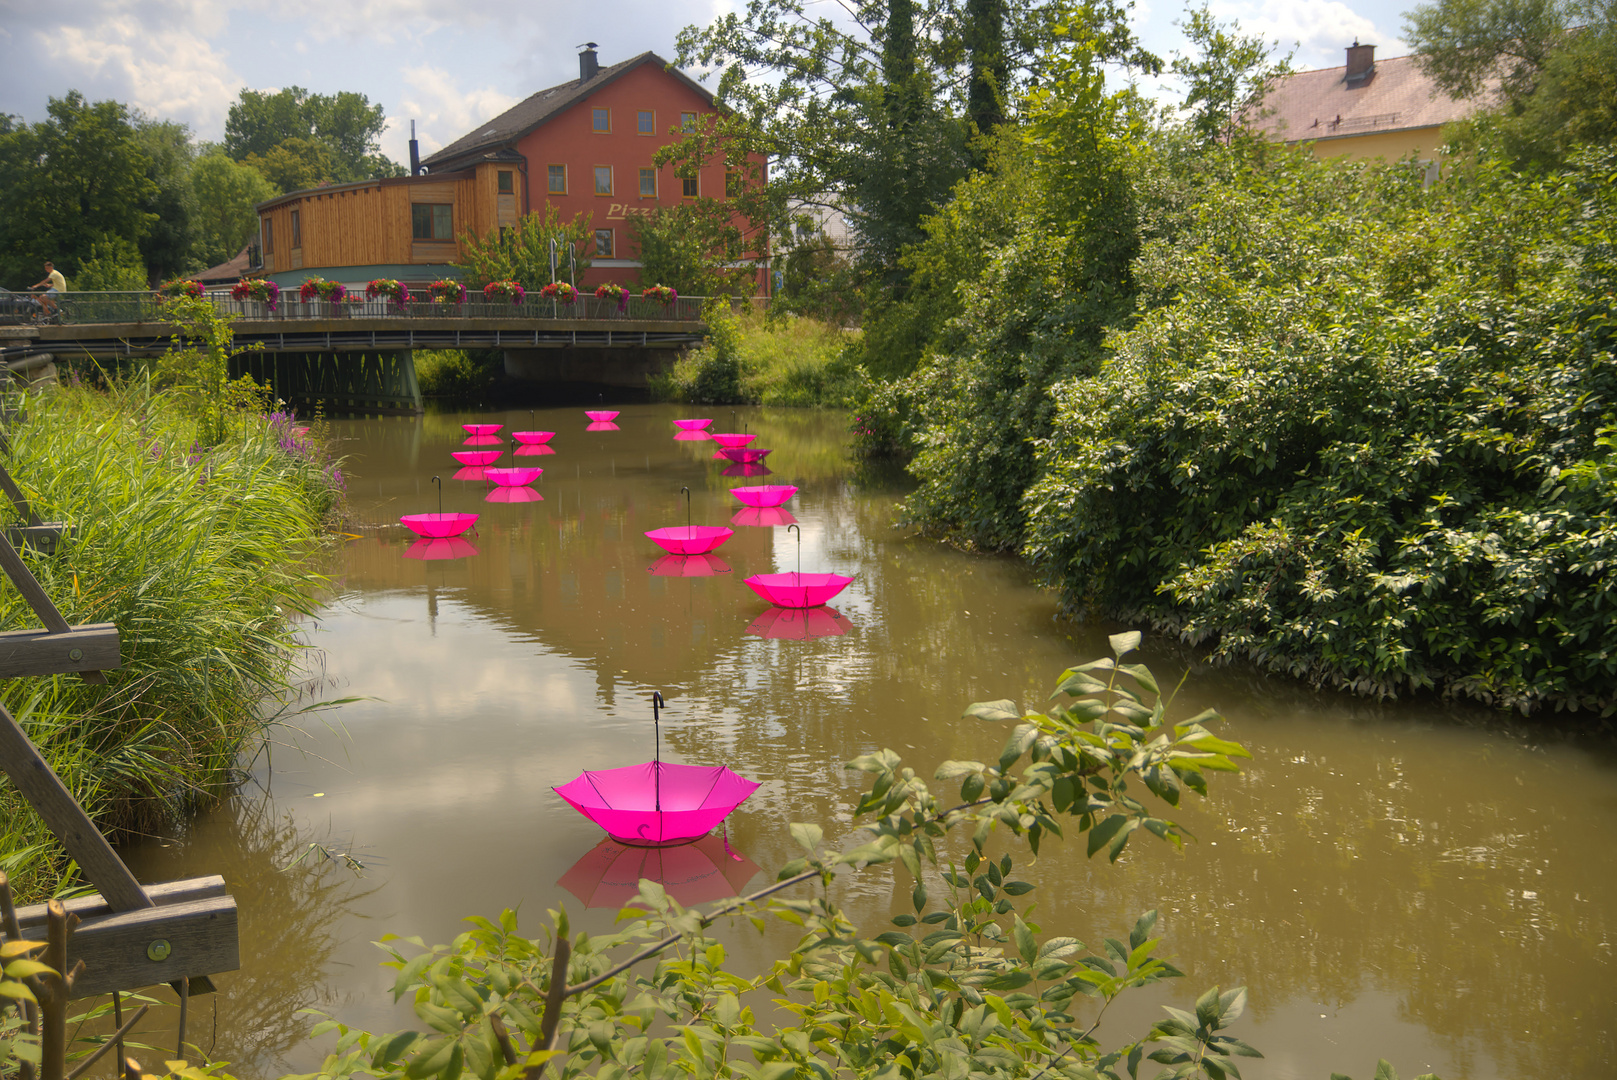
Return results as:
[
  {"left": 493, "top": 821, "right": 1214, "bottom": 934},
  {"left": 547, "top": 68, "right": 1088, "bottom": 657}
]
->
[{"left": 652, "top": 312, "right": 863, "bottom": 409}]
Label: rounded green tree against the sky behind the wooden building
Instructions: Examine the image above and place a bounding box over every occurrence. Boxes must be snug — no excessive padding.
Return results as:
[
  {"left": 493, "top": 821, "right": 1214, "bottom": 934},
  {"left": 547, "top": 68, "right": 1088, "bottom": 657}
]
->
[{"left": 225, "top": 86, "right": 404, "bottom": 191}]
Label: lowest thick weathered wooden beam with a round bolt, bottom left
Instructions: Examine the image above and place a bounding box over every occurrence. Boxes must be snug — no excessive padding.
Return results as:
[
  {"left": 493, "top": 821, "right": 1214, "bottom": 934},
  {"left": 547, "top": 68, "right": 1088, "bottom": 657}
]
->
[{"left": 23, "top": 896, "right": 241, "bottom": 998}]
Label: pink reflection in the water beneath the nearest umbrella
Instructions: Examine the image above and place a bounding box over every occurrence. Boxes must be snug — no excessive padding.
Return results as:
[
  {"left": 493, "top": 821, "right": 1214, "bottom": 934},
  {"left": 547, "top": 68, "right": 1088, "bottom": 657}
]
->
[{"left": 556, "top": 836, "right": 758, "bottom": 909}]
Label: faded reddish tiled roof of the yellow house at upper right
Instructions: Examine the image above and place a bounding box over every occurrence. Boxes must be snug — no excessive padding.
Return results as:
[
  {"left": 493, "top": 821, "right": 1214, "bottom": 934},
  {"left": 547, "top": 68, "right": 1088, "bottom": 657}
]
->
[{"left": 1250, "top": 57, "right": 1497, "bottom": 142}]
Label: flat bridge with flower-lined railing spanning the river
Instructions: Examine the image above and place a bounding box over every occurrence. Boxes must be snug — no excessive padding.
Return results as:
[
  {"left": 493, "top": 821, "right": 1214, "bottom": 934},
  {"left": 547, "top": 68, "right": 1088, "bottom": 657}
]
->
[{"left": 0, "top": 291, "right": 707, "bottom": 412}]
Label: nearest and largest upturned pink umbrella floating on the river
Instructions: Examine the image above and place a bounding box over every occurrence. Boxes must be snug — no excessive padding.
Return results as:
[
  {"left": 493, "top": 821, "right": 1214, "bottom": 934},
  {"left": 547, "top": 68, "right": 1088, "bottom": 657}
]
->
[{"left": 555, "top": 690, "right": 758, "bottom": 847}]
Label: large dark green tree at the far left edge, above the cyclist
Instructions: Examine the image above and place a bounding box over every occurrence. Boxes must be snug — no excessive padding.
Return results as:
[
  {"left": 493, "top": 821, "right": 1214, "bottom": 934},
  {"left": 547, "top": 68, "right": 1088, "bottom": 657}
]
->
[{"left": 0, "top": 91, "right": 157, "bottom": 281}]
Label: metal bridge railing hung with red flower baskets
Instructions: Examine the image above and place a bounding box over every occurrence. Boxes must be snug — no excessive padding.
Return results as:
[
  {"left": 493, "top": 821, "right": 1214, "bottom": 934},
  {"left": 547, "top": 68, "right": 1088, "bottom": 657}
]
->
[{"left": 18, "top": 289, "right": 705, "bottom": 325}]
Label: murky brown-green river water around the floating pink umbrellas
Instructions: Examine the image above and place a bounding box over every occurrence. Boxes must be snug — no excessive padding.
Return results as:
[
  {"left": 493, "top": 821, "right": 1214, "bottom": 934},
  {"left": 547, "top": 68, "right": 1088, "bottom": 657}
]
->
[{"left": 119, "top": 406, "right": 1617, "bottom": 1080}]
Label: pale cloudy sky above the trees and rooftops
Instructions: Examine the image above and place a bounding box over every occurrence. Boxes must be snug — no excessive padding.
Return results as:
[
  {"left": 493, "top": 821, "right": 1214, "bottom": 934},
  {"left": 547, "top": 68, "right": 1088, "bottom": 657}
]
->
[{"left": 0, "top": 0, "right": 1410, "bottom": 163}]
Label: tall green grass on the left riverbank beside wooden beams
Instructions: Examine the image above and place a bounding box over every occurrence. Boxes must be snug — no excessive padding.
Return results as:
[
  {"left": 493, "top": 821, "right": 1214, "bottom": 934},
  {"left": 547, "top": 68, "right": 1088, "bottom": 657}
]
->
[{"left": 0, "top": 383, "right": 343, "bottom": 897}]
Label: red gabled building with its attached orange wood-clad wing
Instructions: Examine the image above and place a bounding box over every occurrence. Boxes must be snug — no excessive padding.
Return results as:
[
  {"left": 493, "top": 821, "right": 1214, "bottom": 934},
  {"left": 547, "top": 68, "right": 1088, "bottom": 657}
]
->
[{"left": 257, "top": 47, "right": 768, "bottom": 289}]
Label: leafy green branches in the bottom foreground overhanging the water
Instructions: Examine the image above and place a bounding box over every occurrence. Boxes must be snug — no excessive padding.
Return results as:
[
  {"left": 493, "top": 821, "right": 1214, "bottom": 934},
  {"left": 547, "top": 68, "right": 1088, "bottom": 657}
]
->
[{"left": 281, "top": 634, "right": 1287, "bottom": 1080}]
